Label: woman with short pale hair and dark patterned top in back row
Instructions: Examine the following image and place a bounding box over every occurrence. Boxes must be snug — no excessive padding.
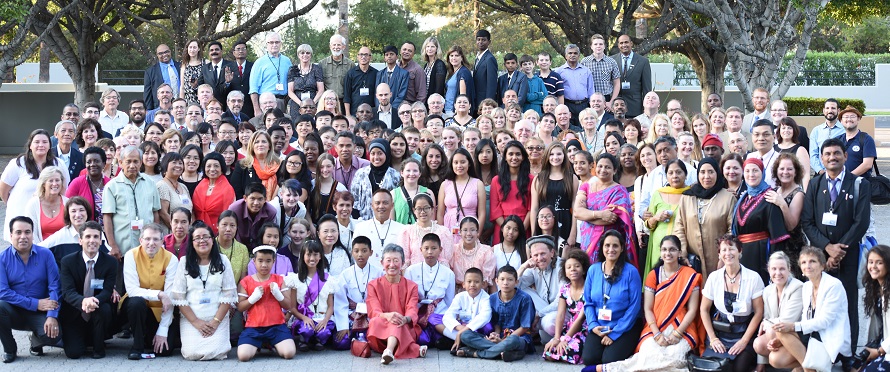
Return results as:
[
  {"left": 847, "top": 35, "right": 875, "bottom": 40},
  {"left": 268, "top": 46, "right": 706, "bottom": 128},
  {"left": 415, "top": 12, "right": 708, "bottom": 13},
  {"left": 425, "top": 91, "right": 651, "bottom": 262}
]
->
[{"left": 287, "top": 44, "right": 324, "bottom": 118}]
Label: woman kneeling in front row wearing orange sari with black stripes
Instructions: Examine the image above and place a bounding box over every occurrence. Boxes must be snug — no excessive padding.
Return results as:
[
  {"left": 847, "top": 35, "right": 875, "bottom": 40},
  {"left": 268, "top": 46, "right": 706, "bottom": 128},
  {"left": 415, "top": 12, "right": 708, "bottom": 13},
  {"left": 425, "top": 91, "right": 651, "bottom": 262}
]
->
[{"left": 597, "top": 235, "right": 705, "bottom": 372}]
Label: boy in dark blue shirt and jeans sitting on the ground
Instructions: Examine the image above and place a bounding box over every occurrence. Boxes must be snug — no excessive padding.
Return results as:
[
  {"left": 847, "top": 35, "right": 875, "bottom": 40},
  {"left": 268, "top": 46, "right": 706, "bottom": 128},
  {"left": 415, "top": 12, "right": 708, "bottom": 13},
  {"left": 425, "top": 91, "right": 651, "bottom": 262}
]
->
[{"left": 456, "top": 265, "right": 535, "bottom": 362}]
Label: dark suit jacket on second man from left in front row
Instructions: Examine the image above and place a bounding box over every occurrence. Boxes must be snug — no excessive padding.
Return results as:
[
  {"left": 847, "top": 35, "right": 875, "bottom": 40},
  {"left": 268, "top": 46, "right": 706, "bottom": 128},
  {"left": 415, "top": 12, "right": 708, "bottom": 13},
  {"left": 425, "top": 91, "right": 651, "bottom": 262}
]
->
[{"left": 59, "top": 250, "right": 118, "bottom": 317}]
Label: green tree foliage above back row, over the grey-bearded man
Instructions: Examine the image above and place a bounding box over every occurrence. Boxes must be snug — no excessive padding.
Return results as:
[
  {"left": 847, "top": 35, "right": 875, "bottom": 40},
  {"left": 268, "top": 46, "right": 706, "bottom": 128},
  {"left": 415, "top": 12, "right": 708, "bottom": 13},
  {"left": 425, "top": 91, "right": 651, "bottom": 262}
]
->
[{"left": 348, "top": 0, "right": 418, "bottom": 54}]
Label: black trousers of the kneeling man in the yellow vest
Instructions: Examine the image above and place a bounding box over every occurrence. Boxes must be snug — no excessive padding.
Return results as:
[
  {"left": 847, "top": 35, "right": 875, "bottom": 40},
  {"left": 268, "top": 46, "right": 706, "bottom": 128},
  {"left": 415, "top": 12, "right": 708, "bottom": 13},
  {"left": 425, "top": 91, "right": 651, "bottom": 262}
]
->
[{"left": 123, "top": 297, "right": 181, "bottom": 356}]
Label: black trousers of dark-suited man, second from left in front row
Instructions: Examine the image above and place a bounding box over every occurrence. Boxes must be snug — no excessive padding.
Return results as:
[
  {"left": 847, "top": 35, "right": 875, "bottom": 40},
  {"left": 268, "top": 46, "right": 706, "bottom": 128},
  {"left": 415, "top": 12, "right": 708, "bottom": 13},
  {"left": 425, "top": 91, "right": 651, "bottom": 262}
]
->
[{"left": 59, "top": 303, "right": 112, "bottom": 359}]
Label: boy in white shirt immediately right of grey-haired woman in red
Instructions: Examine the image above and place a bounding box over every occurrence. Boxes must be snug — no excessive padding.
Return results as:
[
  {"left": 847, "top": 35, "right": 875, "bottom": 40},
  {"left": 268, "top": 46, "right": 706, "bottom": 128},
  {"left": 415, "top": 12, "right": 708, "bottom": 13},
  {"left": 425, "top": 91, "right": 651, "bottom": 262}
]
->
[{"left": 405, "top": 233, "right": 454, "bottom": 345}]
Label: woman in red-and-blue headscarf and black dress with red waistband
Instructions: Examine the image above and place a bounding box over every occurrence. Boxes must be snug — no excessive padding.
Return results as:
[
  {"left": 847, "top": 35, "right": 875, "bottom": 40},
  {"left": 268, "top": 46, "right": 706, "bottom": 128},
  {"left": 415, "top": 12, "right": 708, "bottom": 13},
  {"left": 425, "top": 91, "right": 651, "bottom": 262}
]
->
[{"left": 732, "top": 158, "right": 791, "bottom": 285}]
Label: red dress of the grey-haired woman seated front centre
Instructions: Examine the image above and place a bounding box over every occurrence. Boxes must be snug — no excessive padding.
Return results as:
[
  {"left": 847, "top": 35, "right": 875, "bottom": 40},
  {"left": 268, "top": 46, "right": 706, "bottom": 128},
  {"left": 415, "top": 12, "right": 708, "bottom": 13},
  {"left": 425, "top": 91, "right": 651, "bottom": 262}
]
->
[{"left": 367, "top": 276, "right": 421, "bottom": 359}]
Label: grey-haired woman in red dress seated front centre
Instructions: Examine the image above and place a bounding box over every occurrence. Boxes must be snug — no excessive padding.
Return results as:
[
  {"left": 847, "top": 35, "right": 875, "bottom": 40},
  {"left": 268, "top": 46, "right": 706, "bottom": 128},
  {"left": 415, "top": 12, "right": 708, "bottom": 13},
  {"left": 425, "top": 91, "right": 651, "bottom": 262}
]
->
[{"left": 367, "top": 244, "right": 427, "bottom": 364}]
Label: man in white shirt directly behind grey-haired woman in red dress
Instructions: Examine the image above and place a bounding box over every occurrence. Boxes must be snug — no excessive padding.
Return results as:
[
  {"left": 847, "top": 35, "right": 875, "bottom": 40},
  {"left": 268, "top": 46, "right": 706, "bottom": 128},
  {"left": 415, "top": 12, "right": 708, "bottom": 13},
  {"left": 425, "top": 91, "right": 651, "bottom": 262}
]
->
[{"left": 353, "top": 189, "right": 405, "bottom": 267}]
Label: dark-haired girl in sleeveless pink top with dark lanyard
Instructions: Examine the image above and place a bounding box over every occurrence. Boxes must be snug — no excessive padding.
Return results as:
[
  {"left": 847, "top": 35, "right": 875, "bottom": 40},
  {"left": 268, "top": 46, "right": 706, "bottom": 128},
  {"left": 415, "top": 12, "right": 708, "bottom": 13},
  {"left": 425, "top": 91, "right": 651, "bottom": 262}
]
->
[{"left": 436, "top": 149, "right": 485, "bottom": 244}]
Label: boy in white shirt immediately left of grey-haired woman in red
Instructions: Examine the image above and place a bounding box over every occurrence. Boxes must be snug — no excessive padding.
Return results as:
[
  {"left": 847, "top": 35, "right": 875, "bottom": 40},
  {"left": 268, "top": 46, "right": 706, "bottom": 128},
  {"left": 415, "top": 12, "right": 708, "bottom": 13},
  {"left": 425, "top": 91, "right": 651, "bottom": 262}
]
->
[{"left": 334, "top": 236, "right": 383, "bottom": 342}]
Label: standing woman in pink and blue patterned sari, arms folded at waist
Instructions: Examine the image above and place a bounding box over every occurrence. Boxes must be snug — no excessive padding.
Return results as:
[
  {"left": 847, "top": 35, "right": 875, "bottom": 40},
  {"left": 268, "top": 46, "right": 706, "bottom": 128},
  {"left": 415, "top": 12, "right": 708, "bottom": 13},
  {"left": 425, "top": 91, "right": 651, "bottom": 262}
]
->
[{"left": 572, "top": 154, "right": 638, "bottom": 266}]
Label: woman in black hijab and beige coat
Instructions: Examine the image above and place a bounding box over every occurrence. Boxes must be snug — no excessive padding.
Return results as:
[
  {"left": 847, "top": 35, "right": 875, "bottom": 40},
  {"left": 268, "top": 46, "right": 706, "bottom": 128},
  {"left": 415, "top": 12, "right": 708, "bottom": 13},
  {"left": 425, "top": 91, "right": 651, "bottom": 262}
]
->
[{"left": 674, "top": 157, "right": 737, "bottom": 282}]
